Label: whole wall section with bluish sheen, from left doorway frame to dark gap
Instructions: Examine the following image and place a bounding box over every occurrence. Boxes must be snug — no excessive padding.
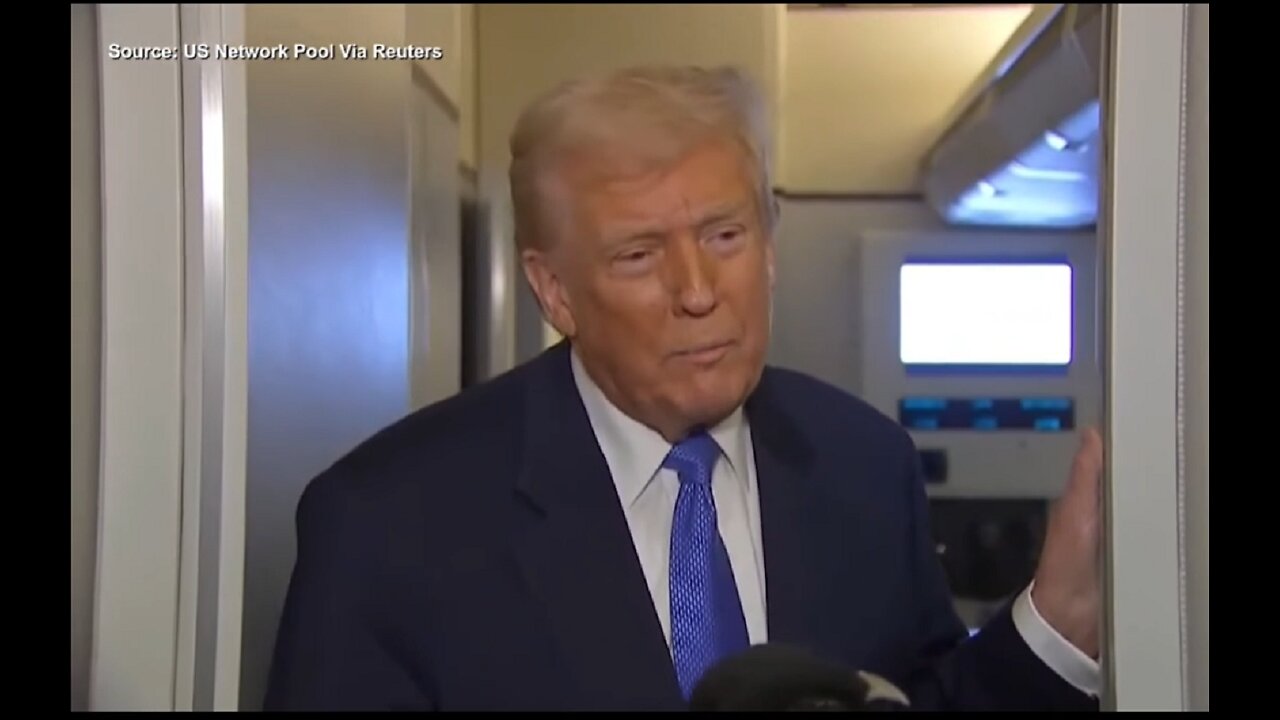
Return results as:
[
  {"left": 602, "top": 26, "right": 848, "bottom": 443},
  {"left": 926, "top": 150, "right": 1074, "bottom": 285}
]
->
[{"left": 232, "top": 5, "right": 473, "bottom": 710}]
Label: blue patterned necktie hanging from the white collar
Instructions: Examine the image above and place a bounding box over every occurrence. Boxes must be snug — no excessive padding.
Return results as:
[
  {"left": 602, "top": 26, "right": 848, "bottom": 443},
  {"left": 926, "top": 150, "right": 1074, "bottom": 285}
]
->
[{"left": 663, "top": 432, "right": 749, "bottom": 698}]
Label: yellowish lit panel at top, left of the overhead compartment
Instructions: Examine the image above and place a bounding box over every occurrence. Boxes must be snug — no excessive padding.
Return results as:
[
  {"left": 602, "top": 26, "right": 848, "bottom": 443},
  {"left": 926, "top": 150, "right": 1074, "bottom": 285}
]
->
[{"left": 780, "top": 5, "right": 1033, "bottom": 193}]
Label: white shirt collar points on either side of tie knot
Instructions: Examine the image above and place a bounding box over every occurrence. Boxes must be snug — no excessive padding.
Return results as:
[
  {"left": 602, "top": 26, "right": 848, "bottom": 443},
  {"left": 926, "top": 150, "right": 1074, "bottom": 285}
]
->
[{"left": 570, "top": 350, "right": 750, "bottom": 507}]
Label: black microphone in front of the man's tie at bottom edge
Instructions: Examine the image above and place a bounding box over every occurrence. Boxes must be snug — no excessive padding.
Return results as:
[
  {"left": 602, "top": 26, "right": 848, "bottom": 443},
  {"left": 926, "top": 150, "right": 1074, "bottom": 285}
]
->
[{"left": 689, "top": 643, "right": 910, "bottom": 712}]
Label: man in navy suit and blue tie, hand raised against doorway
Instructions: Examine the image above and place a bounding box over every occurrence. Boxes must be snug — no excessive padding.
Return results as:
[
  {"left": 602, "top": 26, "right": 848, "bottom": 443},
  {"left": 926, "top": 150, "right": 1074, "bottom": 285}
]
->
[{"left": 266, "top": 68, "right": 1102, "bottom": 711}]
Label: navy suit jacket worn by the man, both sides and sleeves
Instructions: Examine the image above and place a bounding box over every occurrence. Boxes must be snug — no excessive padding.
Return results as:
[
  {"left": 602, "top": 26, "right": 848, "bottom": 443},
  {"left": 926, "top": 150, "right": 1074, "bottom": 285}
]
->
[{"left": 265, "top": 343, "right": 1097, "bottom": 711}]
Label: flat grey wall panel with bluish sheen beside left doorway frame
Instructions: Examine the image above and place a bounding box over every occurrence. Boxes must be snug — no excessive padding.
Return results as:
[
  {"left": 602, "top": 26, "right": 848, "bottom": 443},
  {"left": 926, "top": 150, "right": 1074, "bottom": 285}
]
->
[{"left": 241, "top": 5, "right": 411, "bottom": 708}]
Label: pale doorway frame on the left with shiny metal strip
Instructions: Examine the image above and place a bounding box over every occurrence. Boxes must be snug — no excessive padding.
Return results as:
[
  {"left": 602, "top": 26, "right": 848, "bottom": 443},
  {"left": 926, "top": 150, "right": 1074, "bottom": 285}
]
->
[{"left": 88, "top": 4, "right": 248, "bottom": 711}]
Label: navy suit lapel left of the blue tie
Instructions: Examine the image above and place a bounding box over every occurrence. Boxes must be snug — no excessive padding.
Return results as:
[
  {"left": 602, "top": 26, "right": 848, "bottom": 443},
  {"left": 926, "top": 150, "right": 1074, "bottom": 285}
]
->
[{"left": 515, "top": 343, "right": 682, "bottom": 710}]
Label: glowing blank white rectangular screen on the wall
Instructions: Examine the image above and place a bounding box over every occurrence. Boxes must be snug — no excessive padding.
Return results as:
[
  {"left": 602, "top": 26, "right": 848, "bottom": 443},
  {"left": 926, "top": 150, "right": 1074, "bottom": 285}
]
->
[{"left": 900, "top": 263, "right": 1071, "bottom": 365}]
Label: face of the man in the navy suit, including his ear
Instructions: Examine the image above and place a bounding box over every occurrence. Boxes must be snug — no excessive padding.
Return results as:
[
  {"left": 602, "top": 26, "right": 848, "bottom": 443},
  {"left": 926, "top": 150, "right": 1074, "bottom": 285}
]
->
[{"left": 531, "top": 137, "right": 773, "bottom": 441}]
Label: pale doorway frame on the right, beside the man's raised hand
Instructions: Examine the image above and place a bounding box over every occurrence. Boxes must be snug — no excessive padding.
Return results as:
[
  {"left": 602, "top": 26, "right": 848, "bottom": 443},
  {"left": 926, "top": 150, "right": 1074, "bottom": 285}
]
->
[{"left": 1098, "top": 4, "right": 1208, "bottom": 711}]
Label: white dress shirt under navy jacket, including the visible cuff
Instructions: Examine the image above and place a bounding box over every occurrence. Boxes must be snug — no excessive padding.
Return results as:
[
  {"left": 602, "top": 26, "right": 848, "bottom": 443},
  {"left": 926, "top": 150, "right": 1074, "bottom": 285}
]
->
[{"left": 570, "top": 352, "right": 1101, "bottom": 697}]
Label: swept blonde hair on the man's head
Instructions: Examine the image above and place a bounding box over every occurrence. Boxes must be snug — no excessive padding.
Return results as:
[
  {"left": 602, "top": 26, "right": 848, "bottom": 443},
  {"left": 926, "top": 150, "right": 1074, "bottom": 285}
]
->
[{"left": 509, "top": 67, "right": 774, "bottom": 250}]
